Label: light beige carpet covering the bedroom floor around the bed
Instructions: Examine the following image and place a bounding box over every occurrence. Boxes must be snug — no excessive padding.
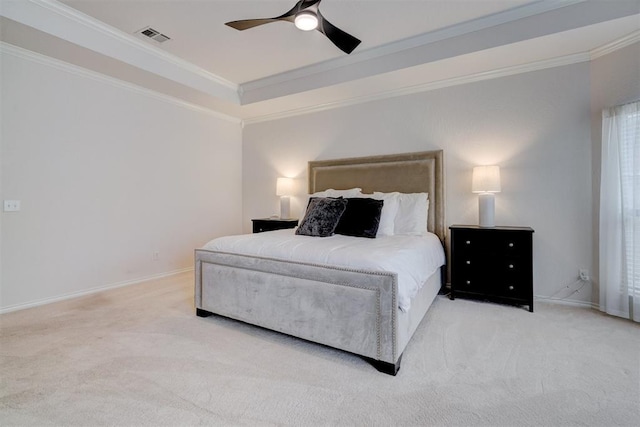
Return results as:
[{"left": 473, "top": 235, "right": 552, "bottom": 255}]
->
[{"left": 0, "top": 274, "right": 640, "bottom": 426}]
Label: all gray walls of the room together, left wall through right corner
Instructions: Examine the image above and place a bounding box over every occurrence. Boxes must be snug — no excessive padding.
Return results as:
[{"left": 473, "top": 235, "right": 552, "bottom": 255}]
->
[{"left": 0, "top": 40, "right": 640, "bottom": 310}]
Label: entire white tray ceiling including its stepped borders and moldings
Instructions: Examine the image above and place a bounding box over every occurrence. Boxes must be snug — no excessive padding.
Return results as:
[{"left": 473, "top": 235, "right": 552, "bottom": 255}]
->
[{"left": 0, "top": 0, "right": 640, "bottom": 122}]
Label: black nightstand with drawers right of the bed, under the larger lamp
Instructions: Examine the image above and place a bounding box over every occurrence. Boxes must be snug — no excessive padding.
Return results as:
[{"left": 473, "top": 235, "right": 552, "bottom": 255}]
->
[{"left": 449, "top": 225, "right": 533, "bottom": 312}]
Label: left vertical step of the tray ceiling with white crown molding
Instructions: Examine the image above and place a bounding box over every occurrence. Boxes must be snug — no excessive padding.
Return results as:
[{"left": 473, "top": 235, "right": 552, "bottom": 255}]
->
[{"left": 0, "top": 0, "right": 240, "bottom": 104}]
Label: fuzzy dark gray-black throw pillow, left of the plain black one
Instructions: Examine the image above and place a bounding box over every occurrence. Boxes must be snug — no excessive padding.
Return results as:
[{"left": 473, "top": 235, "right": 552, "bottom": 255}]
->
[{"left": 296, "top": 197, "right": 347, "bottom": 237}]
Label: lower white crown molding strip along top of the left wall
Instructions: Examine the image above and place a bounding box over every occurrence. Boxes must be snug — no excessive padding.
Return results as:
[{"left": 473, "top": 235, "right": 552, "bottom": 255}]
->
[{"left": 0, "top": 41, "right": 241, "bottom": 124}]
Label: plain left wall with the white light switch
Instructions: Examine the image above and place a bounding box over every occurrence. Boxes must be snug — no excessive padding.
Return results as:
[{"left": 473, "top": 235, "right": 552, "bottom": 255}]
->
[{"left": 0, "top": 48, "right": 242, "bottom": 310}]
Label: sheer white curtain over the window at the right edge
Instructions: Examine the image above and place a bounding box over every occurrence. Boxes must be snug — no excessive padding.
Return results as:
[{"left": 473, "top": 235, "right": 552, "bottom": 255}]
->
[{"left": 599, "top": 102, "right": 640, "bottom": 322}]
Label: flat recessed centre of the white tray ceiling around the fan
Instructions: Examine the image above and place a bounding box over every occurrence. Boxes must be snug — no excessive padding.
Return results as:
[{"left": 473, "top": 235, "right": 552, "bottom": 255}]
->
[{"left": 63, "top": 0, "right": 530, "bottom": 84}]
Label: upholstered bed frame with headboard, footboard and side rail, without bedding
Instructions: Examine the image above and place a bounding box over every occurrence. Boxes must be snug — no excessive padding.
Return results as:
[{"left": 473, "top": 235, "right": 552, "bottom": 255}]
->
[{"left": 195, "top": 150, "right": 445, "bottom": 375}]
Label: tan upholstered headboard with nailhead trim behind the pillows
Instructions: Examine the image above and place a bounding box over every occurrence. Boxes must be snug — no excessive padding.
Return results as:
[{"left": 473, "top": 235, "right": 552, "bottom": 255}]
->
[{"left": 309, "top": 150, "right": 446, "bottom": 242}]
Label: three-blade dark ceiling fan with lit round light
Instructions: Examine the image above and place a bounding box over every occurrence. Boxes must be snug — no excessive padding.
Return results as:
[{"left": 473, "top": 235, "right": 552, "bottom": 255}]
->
[{"left": 225, "top": 0, "right": 360, "bottom": 53}]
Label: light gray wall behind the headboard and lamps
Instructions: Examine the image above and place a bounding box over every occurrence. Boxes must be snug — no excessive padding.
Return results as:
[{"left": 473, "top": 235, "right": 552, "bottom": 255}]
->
[{"left": 243, "top": 63, "right": 593, "bottom": 302}]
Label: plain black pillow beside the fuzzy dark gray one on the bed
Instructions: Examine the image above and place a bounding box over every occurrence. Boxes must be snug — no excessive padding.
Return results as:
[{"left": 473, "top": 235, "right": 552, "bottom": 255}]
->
[{"left": 335, "top": 198, "right": 384, "bottom": 239}]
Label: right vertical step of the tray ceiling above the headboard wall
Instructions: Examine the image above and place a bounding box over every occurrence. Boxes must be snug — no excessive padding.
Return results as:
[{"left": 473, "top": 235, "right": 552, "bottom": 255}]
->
[{"left": 240, "top": 0, "right": 640, "bottom": 105}]
